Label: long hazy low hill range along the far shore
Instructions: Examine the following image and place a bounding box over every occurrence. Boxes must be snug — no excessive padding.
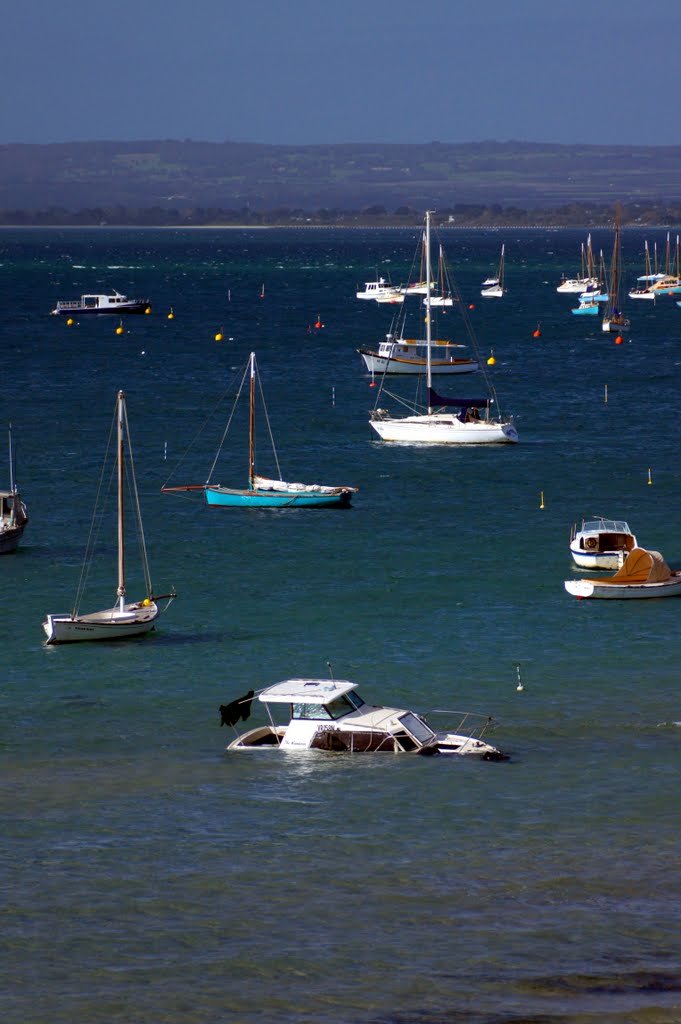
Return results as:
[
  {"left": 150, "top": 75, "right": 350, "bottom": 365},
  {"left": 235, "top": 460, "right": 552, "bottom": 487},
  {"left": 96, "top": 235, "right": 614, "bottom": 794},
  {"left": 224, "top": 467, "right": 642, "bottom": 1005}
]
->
[{"left": 0, "top": 140, "right": 681, "bottom": 222}]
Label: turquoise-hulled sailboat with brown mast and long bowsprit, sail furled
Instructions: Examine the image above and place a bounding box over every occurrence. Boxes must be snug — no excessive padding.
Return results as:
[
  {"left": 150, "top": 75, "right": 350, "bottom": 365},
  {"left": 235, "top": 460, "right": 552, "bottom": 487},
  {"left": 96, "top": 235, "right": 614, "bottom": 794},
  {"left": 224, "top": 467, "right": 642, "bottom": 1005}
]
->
[{"left": 161, "top": 352, "right": 358, "bottom": 509}]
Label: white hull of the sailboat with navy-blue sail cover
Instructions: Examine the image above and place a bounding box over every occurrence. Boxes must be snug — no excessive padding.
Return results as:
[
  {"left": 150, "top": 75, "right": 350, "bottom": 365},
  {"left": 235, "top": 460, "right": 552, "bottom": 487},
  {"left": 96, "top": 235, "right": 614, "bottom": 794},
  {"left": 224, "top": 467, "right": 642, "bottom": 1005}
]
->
[{"left": 370, "top": 414, "right": 518, "bottom": 444}]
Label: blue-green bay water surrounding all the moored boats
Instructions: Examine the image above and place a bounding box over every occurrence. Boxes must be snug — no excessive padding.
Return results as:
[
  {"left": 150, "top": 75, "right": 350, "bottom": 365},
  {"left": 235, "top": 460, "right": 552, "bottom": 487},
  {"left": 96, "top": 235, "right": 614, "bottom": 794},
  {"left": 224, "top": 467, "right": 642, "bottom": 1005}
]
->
[{"left": 0, "top": 229, "right": 681, "bottom": 1024}]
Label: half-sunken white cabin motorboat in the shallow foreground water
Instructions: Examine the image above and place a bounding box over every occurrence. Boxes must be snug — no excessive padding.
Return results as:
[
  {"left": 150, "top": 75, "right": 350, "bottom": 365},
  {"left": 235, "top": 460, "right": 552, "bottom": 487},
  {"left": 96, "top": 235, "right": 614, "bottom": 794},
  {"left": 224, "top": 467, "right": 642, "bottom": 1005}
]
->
[{"left": 220, "top": 678, "right": 507, "bottom": 761}]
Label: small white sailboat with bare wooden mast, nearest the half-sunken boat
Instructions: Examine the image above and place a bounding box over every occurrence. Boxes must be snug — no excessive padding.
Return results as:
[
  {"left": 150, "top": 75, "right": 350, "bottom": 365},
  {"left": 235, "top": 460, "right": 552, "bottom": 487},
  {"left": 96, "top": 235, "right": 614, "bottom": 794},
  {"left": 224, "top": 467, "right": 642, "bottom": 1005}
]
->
[{"left": 43, "top": 391, "right": 176, "bottom": 644}]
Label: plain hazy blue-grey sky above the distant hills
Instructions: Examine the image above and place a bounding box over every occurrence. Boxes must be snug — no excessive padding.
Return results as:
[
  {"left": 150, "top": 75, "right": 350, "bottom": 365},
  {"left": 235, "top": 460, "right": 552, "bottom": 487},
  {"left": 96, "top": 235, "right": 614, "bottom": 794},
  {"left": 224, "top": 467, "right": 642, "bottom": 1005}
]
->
[{"left": 5, "top": 0, "right": 681, "bottom": 144}]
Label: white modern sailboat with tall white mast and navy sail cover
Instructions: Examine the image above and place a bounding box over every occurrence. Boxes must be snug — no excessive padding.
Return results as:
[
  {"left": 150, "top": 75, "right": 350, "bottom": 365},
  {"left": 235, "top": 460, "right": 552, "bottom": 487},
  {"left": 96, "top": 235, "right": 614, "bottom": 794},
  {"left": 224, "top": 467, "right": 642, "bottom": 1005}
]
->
[{"left": 370, "top": 213, "right": 518, "bottom": 444}]
